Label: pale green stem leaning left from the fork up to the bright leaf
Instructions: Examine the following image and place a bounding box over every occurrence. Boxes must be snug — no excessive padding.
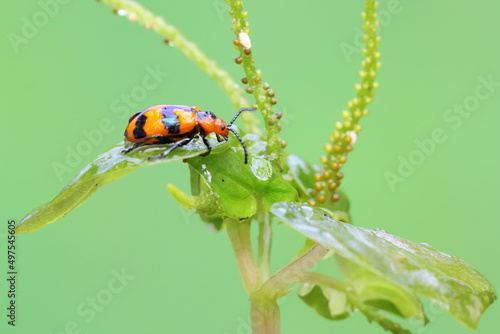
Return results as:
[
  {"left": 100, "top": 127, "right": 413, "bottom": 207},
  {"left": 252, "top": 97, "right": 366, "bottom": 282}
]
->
[{"left": 224, "top": 218, "right": 260, "bottom": 296}]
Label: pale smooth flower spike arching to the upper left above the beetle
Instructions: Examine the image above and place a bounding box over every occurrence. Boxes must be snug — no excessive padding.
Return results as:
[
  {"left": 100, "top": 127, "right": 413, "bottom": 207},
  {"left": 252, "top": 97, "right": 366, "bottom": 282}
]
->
[{"left": 102, "top": 0, "right": 261, "bottom": 135}]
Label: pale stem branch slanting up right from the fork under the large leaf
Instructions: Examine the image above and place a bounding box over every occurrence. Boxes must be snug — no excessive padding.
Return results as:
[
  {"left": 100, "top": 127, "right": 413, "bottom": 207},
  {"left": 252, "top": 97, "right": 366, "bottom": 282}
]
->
[{"left": 254, "top": 244, "right": 328, "bottom": 298}]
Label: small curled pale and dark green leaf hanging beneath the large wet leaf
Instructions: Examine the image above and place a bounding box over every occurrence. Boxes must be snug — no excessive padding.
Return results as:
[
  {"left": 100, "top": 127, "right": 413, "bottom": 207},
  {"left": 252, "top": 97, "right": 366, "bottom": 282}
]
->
[{"left": 297, "top": 283, "right": 349, "bottom": 320}]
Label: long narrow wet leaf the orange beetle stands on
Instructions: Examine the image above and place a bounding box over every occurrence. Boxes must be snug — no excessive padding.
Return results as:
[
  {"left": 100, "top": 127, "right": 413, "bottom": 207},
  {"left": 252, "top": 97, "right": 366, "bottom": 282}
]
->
[{"left": 16, "top": 141, "right": 228, "bottom": 234}]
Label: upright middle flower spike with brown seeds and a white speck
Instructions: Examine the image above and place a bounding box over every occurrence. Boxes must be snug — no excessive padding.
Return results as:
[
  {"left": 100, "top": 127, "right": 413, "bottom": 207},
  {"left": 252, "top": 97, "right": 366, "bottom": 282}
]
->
[{"left": 226, "top": 0, "right": 282, "bottom": 168}]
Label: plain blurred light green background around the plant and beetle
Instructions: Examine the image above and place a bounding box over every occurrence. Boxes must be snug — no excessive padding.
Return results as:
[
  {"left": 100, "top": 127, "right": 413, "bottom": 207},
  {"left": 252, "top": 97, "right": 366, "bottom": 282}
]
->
[{"left": 0, "top": 0, "right": 500, "bottom": 334}]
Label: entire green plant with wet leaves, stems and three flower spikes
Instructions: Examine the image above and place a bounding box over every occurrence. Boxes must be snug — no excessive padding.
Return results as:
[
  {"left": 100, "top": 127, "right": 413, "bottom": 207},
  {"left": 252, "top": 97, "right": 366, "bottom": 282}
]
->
[{"left": 16, "top": 0, "right": 496, "bottom": 333}]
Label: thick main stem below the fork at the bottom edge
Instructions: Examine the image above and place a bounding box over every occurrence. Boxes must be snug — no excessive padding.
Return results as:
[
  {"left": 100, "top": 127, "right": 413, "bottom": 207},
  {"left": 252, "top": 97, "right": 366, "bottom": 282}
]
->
[{"left": 250, "top": 298, "right": 280, "bottom": 334}]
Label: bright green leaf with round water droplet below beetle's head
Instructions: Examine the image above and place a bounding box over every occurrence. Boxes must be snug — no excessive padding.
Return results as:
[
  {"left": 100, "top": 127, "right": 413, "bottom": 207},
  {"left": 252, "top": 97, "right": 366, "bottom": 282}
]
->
[{"left": 188, "top": 140, "right": 297, "bottom": 219}]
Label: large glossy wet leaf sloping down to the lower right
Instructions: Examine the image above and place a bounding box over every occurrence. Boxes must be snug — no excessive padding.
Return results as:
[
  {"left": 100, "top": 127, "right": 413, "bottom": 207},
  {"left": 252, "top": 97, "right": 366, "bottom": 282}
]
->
[{"left": 271, "top": 203, "right": 497, "bottom": 329}]
